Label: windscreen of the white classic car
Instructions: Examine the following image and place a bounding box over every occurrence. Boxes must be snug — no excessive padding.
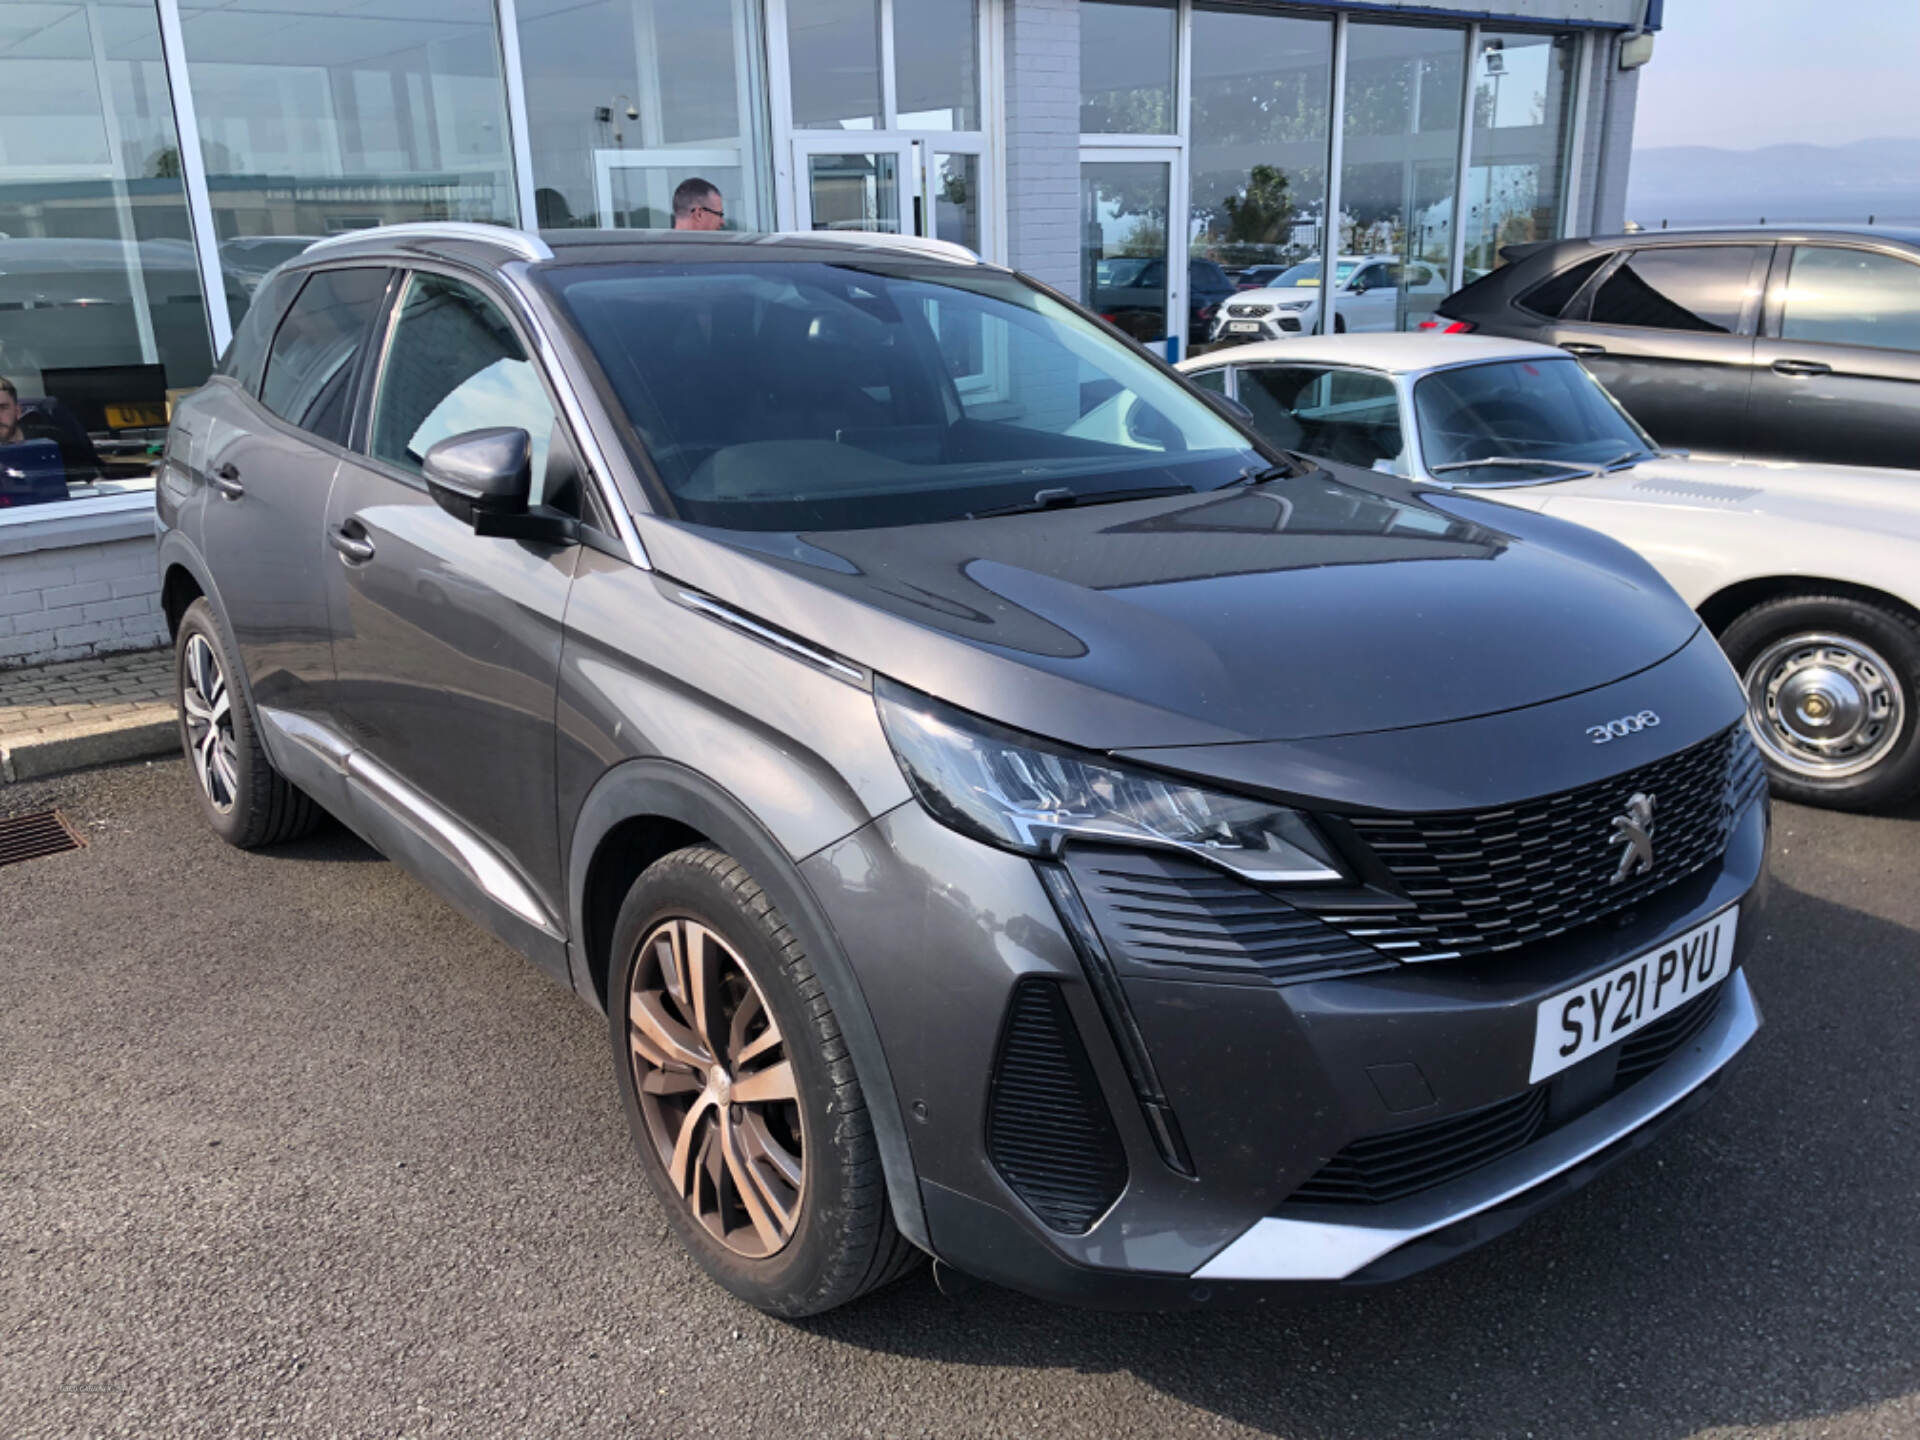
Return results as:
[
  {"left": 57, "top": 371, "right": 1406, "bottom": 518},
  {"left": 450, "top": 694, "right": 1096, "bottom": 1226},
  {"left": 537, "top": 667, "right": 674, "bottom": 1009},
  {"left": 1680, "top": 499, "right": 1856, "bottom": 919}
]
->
[{"left": 1413, "top": 357, "right": 1653, "bottom": 484}]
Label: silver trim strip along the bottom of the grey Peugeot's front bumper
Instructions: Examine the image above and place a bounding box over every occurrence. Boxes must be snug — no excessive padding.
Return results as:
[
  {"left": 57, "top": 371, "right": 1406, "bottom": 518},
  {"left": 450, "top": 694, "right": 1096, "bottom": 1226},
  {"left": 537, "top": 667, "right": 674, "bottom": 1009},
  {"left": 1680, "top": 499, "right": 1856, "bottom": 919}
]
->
[{"left": 1192, "top": 970, "right": 1761, "bottom": 1281}]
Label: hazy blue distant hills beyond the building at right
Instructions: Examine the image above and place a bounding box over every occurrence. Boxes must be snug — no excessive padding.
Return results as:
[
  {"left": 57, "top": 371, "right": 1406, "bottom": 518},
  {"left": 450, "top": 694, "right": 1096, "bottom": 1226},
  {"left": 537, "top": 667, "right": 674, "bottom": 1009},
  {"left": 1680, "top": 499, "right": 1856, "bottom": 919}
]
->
[{"left": 1626, "top": 138, "right": 1920, "bottom": 230}]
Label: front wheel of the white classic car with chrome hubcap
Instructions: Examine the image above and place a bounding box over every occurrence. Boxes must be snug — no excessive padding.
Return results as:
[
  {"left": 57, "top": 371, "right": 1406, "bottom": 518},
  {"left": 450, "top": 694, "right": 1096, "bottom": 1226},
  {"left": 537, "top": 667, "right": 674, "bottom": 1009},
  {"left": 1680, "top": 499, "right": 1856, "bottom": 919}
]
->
[{"left": 1720, "top": 595, "right": 1920, "bottom": 810}]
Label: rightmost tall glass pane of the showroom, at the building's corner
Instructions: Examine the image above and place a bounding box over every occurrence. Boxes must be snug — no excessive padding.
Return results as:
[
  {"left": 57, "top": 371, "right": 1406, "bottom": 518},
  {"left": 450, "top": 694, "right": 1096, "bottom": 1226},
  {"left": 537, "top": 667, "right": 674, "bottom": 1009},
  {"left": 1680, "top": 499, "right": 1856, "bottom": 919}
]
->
[{"left": 1463, "top": 31, "right": 1574, "bottom": 280}]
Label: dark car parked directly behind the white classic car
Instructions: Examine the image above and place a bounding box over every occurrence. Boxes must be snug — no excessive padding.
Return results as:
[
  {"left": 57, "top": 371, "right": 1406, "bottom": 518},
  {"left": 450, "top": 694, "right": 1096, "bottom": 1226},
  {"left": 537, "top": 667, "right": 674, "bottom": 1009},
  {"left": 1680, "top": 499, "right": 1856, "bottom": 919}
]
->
[{"left": 1421, "top": 228, "right": 1920, "bottom": 468}]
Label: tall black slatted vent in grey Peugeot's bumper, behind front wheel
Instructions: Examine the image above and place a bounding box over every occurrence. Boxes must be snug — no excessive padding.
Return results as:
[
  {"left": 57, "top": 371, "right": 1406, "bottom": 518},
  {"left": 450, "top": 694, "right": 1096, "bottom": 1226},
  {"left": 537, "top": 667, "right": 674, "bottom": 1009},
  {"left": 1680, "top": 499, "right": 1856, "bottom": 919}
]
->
[{"left": 987, "top": 979, "right": 1127, "bottom": 1235}]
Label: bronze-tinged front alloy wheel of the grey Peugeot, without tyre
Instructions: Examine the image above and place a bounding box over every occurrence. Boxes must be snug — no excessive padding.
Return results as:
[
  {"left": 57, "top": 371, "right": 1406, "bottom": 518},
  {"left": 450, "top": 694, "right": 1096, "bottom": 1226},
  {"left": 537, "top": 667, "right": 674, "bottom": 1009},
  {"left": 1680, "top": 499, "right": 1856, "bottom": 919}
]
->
[{"left": 628, "top": 916, "right": 806, "bottom": 1260}]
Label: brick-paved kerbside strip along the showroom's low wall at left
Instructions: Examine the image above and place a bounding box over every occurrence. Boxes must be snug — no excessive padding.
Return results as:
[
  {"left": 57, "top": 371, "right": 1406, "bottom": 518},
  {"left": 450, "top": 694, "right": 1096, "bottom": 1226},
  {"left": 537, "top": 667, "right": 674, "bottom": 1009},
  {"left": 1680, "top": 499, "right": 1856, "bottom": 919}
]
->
[{"left": 0, "top": 651, "right": 179, "bottom": 783}]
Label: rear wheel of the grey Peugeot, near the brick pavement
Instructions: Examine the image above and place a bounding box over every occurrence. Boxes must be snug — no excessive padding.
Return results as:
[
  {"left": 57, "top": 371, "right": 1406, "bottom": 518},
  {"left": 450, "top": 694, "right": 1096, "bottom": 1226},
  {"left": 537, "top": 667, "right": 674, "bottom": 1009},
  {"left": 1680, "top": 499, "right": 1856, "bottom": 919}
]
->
[{"left": 173, "top": 599, "right": 321, "bottom": 851}]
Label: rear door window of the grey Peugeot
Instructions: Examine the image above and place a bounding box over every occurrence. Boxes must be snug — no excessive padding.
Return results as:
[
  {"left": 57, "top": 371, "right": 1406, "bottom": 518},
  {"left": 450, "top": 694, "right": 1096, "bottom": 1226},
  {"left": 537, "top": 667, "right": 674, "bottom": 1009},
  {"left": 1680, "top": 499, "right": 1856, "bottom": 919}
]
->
[{"left": 259, "top": 267, "right": 388, "bottom": 445}]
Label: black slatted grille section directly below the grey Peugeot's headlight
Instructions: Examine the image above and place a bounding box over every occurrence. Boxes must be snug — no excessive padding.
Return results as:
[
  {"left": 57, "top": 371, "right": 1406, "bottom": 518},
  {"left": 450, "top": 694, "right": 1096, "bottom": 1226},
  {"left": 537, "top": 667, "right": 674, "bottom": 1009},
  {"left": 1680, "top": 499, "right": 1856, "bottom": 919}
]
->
[{"left": 1068, "top": 849, "right": 1394, "bottom": 981}]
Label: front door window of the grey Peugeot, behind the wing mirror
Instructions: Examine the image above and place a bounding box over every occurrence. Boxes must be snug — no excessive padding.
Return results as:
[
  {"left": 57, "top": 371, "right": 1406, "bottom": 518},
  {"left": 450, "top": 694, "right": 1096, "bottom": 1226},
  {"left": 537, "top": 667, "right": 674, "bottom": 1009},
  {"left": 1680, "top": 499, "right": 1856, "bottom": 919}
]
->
[{"left": 371, "top": 273, "right": 566, "bottom": 505}]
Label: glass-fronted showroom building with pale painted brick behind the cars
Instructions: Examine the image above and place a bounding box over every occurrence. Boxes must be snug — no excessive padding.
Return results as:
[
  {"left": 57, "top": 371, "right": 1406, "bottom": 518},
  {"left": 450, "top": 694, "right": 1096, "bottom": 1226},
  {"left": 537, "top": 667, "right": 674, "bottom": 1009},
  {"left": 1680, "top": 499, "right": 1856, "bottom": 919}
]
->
[{"left": 0, "top": 0, "right": 1659, "bottom": 664}]
